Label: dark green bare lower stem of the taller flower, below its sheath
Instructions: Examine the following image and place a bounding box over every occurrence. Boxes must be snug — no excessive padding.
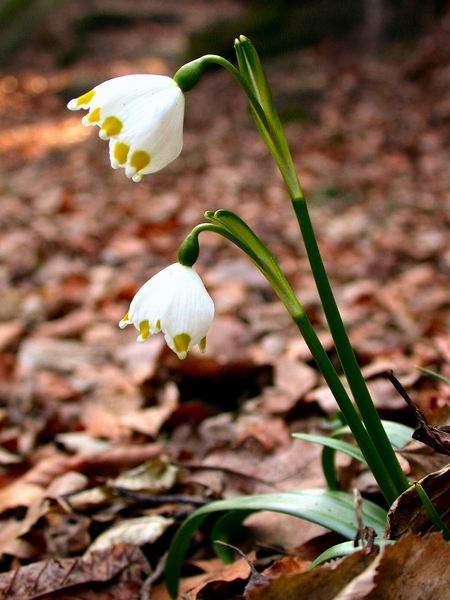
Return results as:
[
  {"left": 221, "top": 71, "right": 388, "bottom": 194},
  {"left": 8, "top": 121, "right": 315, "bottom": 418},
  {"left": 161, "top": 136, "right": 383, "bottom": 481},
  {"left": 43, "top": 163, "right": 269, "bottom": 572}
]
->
[{"left": 292, "top": 196, "right": 408, "bottom": 495}]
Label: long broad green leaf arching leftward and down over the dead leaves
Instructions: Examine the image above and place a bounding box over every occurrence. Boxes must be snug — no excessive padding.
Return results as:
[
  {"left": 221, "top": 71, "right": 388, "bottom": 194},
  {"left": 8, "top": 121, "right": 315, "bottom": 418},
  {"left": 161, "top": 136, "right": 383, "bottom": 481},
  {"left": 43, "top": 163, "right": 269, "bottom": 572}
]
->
[{"left": 165, "top": 490, "right": 386, "bottom": 598}]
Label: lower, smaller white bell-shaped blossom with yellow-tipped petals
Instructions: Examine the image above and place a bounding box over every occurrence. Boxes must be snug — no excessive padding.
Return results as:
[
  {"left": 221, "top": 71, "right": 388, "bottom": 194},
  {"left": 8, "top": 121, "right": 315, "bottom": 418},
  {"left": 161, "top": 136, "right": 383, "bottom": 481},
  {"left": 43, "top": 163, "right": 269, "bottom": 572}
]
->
[{"left": 119, "top": 263, "right": 214, "bottom": 359}]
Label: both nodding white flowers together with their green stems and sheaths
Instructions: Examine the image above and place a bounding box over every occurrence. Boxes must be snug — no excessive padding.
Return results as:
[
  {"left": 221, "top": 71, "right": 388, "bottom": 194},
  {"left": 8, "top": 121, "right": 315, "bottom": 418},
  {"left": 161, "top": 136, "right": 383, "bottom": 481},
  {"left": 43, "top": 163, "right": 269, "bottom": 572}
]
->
[{"left": 68, "top": 36, "right": 408, "bottom": 502}]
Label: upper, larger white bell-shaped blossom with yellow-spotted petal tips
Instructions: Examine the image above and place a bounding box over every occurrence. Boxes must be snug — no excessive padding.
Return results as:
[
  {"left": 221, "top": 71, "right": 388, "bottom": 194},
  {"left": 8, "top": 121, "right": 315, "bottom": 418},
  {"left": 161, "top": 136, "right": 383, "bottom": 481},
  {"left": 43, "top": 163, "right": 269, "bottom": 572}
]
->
[{"left": 67, "top": 75, "right": 184, "bottom": 181}]
